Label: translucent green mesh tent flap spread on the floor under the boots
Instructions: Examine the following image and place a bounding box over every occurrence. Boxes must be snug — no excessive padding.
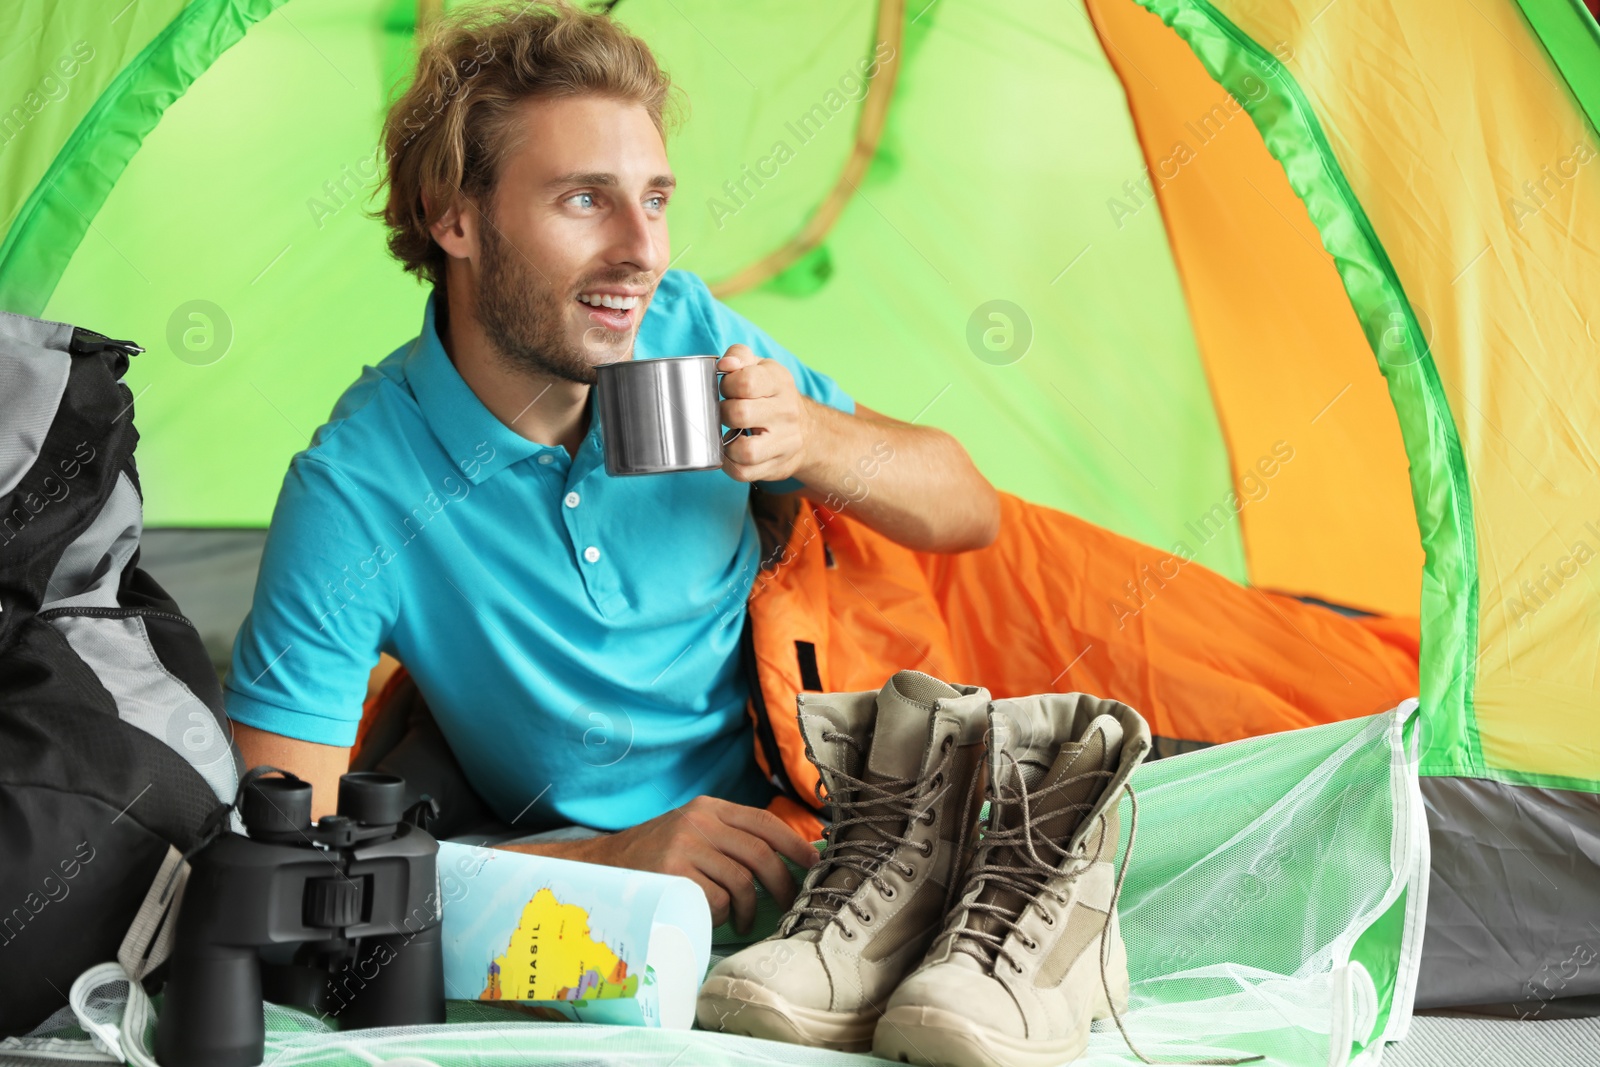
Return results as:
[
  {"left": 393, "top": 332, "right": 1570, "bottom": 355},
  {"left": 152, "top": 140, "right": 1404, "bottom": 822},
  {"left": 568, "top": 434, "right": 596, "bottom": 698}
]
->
[{"left": 0, "top": 701, "right": 1427, "bottom": 1067}]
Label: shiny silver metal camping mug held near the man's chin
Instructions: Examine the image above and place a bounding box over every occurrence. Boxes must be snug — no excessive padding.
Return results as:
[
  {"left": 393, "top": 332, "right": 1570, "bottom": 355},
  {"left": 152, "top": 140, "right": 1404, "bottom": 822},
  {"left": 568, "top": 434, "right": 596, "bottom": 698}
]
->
[{"left": 595, "top": 355, "right": 749, "bottom": 477}]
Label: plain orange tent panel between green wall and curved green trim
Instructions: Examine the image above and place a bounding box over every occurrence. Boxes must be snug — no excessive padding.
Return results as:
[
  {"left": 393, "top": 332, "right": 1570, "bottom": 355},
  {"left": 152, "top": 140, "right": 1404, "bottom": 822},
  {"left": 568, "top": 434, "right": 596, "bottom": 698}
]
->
[{"left": 1088, "top": 0, "right": 1422, "bottom": 616}]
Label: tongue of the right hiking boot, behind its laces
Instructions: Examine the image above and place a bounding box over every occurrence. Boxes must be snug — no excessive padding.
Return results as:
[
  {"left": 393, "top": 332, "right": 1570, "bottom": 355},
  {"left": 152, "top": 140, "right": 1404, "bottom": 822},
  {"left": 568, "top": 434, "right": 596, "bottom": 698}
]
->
[{"left": 952, "top": 715, "right": 1122, "bottom": 969}]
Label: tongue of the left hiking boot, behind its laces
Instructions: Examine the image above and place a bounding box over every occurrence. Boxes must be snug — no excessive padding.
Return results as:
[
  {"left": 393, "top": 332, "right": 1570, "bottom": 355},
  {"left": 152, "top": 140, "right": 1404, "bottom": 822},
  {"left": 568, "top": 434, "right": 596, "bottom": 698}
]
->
[{"left": 802, "top": 670, "right": 960, "bottom": 936}]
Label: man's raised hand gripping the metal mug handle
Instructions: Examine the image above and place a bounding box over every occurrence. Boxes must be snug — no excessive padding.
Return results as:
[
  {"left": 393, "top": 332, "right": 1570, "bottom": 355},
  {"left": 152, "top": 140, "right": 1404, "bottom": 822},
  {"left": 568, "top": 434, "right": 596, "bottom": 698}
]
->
[{"left": 717, "top": 344, "right": 811, "bottom": 482}]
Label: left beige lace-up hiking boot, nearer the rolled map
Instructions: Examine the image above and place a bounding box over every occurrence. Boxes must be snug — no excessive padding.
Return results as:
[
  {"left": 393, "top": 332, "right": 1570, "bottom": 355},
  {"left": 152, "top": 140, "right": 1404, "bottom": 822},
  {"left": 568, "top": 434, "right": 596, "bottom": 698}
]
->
[{"left": 696, "top": 670, "right": 989, "bottom": 1051}]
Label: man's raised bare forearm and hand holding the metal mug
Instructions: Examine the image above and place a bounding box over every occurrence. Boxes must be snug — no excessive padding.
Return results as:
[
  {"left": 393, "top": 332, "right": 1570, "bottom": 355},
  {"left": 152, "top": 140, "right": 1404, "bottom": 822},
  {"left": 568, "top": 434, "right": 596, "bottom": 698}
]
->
[{"left": 717, "top": 344, "right": 1000, "bottom": 552}]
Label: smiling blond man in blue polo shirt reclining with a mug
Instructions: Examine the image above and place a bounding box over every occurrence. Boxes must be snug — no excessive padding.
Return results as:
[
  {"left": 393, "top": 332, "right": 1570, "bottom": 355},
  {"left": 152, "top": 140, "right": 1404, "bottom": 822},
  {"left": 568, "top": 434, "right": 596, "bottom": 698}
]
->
[{"left": 227, "top": 3, "right": 998, "bottom": 928}]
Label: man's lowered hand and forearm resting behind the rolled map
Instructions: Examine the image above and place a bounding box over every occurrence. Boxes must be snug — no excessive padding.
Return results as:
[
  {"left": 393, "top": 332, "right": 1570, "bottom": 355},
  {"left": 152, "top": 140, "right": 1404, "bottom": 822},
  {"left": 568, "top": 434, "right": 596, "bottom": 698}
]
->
[{"left": 504, "top": 797, "right": 818, "bottom": 934}]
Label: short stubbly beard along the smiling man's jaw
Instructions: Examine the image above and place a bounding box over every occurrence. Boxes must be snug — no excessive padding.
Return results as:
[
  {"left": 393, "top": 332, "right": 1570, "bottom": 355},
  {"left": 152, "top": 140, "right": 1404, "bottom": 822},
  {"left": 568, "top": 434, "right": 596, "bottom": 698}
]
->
[{"left": 478, "top": 219, "right": 624, "bottom": 386}]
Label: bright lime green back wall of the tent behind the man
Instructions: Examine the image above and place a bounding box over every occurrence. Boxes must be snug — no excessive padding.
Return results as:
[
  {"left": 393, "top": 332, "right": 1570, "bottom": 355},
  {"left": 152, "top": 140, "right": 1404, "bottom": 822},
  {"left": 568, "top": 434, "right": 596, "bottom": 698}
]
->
[{"left": 0, "top": 0, "right": 1243, "bottom": 579}]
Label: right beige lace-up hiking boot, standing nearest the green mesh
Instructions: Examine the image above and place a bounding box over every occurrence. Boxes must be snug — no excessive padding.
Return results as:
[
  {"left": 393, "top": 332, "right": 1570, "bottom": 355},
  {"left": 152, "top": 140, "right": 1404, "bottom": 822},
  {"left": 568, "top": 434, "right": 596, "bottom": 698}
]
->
[{"left": 872, "top": 693, "right": 1150, "bottom": 1067}]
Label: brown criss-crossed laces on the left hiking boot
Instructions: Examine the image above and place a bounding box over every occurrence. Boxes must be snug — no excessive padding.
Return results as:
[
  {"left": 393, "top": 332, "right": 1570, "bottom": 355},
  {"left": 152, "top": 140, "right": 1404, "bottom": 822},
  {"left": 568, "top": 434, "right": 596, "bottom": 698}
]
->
[{"left": 784, "top": 731, "right": 955, "bottom": 936}]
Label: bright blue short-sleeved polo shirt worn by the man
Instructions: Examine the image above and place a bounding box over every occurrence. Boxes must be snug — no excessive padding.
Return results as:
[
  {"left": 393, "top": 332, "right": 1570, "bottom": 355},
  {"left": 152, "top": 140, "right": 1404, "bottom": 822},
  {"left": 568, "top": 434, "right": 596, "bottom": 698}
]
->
[{"left": 226, "top": 270, "right": 854, "bottom": 830}]
